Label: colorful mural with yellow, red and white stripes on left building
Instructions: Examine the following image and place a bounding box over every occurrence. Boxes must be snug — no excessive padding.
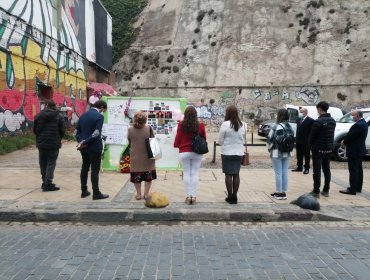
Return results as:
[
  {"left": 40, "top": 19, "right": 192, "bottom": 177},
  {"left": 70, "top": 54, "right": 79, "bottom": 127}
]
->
[{"left": 0, "top": 0, "right": 86, "bottom": 132}]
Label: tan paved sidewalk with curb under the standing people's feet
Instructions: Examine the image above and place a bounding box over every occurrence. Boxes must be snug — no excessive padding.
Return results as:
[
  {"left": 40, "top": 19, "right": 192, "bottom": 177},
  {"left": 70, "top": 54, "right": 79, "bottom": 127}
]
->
[{"left": 0, "top": 143, "right": 370, "bottom": 222}]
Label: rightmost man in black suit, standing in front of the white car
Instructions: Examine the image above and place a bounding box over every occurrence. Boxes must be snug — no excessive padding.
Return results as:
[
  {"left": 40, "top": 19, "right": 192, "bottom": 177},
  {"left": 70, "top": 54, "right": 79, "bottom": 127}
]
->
[{"left": 339, "top": 110, "right": 368, "bottom": 195}]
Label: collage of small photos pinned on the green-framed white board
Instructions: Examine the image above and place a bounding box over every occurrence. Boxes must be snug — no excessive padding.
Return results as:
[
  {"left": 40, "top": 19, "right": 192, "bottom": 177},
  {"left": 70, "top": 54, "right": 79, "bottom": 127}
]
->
[{"left": 144, "top": 100, "right": 177, "bottom": 134}]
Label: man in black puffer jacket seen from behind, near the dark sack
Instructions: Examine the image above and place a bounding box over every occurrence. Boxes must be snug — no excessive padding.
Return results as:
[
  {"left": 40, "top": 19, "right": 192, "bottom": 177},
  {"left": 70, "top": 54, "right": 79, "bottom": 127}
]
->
[{"left": 308, "top": 101, "right": 336, "bottom": 198}]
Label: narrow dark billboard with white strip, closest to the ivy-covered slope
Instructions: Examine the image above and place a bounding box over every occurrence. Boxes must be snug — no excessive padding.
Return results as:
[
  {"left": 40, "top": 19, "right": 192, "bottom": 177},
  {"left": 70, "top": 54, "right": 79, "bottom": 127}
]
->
[{"left": 94, "top": 0, "right": 112, "bottom": 70}]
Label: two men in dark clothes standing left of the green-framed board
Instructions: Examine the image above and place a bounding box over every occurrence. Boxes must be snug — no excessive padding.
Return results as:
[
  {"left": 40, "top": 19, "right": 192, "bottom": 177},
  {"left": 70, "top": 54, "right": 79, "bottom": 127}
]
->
[{"left": 33, "top": 100, "right": 109, "bottom": 200}]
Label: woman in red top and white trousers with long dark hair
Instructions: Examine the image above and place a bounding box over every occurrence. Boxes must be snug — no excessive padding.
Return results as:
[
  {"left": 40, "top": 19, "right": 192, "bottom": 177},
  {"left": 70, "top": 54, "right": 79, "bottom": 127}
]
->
[{"left": 174, "top": 106, "right": 206, "bottom": 204}]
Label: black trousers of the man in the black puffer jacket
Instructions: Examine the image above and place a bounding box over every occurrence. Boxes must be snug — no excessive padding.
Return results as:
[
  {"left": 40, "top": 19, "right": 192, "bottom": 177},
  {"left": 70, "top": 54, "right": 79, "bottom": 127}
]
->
[{"left": 312, "top": 150, "right": 331, "bottom": 193}]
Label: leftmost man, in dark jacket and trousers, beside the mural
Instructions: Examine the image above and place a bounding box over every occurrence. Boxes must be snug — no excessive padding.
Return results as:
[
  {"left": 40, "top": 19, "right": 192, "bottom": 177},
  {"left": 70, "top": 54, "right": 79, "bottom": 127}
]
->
[{"left": 33, "top": 100, "right": 65, "bottom": 192}]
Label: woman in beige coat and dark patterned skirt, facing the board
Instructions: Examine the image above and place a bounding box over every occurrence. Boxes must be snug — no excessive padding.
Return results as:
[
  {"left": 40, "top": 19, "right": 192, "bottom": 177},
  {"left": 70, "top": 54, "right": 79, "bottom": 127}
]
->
[{"left": 128, "top": 111, "right": 157, "bottom": 200}]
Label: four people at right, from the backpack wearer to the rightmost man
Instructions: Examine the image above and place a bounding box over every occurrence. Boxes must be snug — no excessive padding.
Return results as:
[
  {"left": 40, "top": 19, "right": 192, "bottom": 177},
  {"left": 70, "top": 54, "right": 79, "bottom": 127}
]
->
[{"left": 268, "top": 101, "right": 368, "bottom": 200}]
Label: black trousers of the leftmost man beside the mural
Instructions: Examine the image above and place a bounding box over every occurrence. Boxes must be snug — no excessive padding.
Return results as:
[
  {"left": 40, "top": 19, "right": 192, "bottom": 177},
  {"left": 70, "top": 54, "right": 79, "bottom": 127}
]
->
[{"left": 39, "top": 149, "right": 59, "bottom": 186}]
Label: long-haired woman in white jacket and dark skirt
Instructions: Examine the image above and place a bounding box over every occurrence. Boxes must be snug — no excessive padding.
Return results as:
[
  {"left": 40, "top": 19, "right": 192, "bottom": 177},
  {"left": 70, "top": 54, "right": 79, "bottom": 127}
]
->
[{"left": 218, "top": 105, "right": 247, "bottom": 204}]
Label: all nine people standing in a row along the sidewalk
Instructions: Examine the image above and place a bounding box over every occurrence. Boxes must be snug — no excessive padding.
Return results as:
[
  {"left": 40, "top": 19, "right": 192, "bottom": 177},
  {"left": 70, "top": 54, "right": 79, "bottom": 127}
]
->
[{"left": 33, "top": 100, "right": 368, "bottom": 205}]
